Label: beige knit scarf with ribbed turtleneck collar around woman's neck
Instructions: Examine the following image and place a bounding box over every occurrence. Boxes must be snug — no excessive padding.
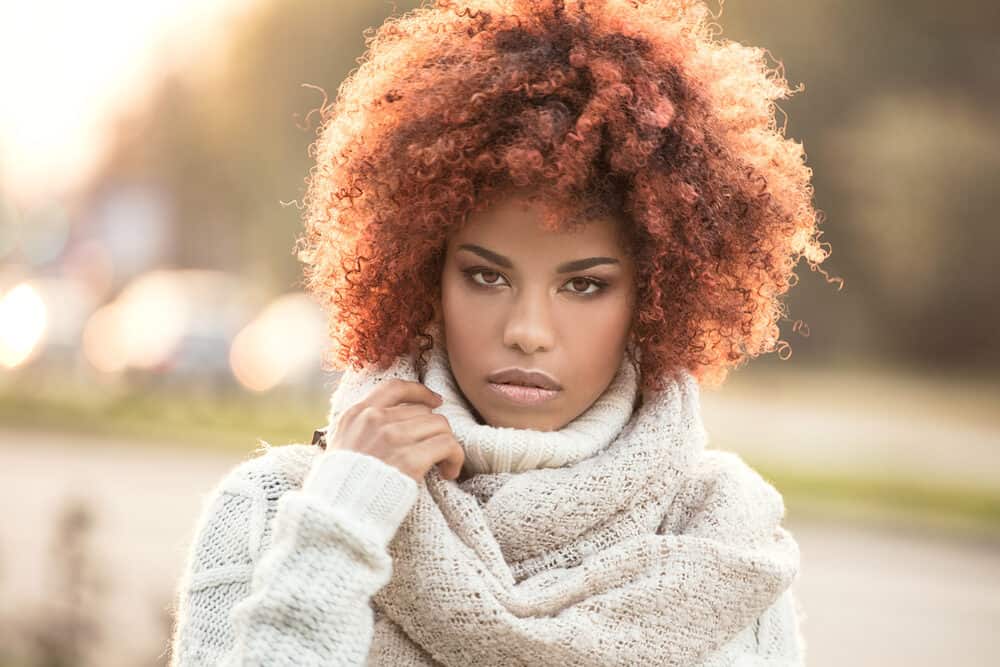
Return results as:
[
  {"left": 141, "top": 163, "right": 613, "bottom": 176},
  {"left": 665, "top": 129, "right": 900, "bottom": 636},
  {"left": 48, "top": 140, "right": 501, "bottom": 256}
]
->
[{"left": 330, "top": 335, "right": 799, "bottom": 667}]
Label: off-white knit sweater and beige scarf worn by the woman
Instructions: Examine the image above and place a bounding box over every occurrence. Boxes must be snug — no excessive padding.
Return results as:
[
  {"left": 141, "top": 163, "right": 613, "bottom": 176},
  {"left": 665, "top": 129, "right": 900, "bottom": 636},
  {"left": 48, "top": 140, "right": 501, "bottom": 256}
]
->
[{"left": 171, "top": 330, "right": 805, "bottom": 667}]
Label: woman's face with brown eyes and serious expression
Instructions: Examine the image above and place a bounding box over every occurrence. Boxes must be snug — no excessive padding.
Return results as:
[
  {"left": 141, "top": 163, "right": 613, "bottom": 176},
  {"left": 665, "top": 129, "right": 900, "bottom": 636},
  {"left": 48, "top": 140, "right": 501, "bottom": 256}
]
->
[{"left": 441, "top": 194, "right": 635, "bottom": 431}]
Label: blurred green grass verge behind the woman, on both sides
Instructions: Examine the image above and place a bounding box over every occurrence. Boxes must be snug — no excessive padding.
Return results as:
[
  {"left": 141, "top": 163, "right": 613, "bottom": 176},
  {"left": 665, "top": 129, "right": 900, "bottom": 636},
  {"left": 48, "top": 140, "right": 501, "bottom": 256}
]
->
[{"left": 0, "top": 389, "right": 1000, "bottom": 532}]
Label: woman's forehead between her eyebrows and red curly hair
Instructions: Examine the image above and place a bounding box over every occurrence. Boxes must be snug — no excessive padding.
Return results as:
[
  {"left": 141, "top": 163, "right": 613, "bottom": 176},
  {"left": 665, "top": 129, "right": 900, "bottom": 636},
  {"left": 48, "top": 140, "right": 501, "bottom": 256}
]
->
[{"left": 449, "top": 195, "right": 624, "bottom": 257}]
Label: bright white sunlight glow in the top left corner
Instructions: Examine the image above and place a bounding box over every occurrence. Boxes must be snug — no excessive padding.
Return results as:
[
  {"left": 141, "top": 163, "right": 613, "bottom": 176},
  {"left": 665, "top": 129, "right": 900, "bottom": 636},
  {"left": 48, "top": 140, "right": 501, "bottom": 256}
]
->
[{"left": 0, "top": 0, "right": 253, "bottom": 200}]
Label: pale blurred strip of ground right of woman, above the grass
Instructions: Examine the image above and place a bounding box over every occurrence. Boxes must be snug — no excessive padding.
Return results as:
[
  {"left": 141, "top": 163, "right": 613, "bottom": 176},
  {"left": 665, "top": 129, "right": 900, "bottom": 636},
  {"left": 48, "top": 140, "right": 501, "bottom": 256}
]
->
[{"left": 701, "top": 379, "right": 1000, "bottom": 490}]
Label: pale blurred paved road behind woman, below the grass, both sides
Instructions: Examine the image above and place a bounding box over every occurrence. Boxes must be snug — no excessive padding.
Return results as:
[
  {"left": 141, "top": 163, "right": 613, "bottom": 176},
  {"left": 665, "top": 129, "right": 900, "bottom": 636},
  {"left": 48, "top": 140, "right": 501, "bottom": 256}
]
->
[{"left": 0, "top": 430, "right": 1000, "bottom": 667}]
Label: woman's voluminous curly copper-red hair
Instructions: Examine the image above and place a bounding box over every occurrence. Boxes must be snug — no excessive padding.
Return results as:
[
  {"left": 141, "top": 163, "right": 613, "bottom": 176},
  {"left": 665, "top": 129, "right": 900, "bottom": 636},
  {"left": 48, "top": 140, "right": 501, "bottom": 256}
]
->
[{"left": 296, "top": 0, "right": 829, "bottom": 389}]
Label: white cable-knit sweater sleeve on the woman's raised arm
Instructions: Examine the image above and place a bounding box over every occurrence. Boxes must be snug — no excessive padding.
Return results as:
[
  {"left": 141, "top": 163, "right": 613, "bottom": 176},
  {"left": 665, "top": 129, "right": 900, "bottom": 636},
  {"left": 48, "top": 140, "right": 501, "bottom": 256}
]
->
[{"left": 170, "top": 450, "right": 418, "bottom": 667}]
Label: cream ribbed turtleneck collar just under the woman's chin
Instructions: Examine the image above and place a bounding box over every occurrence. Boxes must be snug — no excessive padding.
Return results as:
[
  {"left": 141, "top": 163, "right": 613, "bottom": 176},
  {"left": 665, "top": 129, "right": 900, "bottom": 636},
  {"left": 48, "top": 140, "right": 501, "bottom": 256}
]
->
[{"left": 421, "top": 328, "right": 638, "bottom": 475}]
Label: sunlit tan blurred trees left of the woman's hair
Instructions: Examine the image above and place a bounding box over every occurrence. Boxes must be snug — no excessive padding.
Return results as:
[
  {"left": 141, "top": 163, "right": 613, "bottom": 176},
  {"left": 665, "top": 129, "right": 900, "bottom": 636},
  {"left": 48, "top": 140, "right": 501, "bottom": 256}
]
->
[{"left": 93, "top": 0, "right": 418, "bottom": 293}]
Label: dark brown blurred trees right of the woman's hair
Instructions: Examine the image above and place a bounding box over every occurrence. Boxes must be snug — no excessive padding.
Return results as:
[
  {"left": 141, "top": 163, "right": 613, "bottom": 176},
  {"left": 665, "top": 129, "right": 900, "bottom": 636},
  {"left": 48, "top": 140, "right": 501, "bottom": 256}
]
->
[{"left": 719, "top": 0, "right": 1000, "bottom": 372}]
